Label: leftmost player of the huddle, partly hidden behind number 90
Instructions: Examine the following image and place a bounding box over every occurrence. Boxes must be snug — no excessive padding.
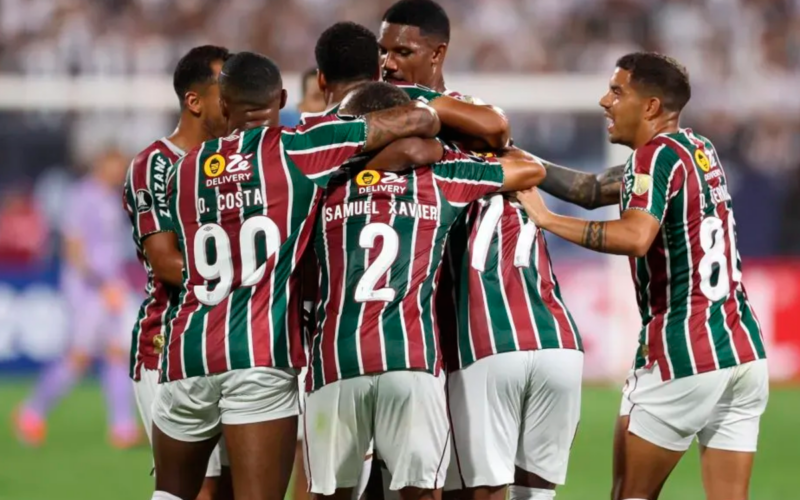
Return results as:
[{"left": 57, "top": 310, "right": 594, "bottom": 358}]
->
[{"left": 124, "top": 45, "right": 230, "bottom": 499}]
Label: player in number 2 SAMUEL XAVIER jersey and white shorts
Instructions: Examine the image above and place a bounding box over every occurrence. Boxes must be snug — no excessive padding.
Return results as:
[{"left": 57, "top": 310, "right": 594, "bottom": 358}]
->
[{"left": 304, "top": 83, "right": 544, "bottom": 499}]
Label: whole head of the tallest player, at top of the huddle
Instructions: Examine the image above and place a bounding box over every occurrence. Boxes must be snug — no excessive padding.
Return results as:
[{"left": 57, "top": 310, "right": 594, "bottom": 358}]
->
[{"left": 378, "top": 0, "right": 450, "bottom": 87}]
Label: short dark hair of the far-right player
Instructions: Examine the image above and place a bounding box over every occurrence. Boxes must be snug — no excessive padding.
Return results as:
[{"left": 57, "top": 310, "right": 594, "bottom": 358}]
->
[{"left": 617, "top": 52, "right": 692, "bottom": 112}]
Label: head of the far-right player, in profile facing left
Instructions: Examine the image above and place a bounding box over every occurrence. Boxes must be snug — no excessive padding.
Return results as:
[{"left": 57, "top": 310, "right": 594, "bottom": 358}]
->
[{"left": 600, "top": 52, "right": 692, "bottom": 147}]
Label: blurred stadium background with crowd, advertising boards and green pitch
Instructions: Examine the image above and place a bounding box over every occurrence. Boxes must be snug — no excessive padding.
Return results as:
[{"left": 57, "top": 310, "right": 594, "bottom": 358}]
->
[{"left": 0, "top": 0, "right": 800, "bottom": 500}]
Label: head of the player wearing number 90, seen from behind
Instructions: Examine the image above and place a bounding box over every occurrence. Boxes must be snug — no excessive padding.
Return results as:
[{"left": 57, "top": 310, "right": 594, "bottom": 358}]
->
[{"left": 219, "top": 52, "right": 286, "bottom": 129}]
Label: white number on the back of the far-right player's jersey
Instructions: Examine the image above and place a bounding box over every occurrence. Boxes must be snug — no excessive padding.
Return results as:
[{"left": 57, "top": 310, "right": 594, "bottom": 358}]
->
[{"left": 698, "top": 212, "right": 742, "bottom": 302}]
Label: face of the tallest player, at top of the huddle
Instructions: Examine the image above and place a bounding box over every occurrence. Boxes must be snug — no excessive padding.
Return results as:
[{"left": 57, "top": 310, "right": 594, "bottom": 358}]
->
[{"left": 378, "top": 23, "right": 436, "bottom": 86}]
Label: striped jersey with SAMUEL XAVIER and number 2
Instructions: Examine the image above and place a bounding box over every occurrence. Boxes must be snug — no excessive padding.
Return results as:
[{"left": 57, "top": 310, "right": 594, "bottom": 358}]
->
[{"left": 307, "top": 149, "right": 503, "bottom": 390}]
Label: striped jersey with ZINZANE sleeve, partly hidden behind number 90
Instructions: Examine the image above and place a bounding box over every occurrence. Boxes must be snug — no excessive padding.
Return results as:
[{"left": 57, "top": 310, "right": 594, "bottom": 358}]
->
[{"left": 123, "top": 138, "right": 183, "bottom": 380}]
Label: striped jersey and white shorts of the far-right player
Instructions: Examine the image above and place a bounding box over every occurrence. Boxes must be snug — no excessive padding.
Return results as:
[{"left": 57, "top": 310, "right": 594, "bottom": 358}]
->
[{"left": 620, "top": 129, "right": 769, "bottom": 452}]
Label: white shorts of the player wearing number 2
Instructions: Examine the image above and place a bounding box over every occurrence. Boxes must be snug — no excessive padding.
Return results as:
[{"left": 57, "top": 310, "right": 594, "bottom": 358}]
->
[{"left": 303, "top": 371, "right": 450, "bottom": 495}]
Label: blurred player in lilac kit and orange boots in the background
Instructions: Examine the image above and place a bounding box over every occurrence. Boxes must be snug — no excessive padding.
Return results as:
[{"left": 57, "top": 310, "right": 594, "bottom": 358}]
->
[{"left": 15, "top": 150, "right": 139, "bottom": 448}]
